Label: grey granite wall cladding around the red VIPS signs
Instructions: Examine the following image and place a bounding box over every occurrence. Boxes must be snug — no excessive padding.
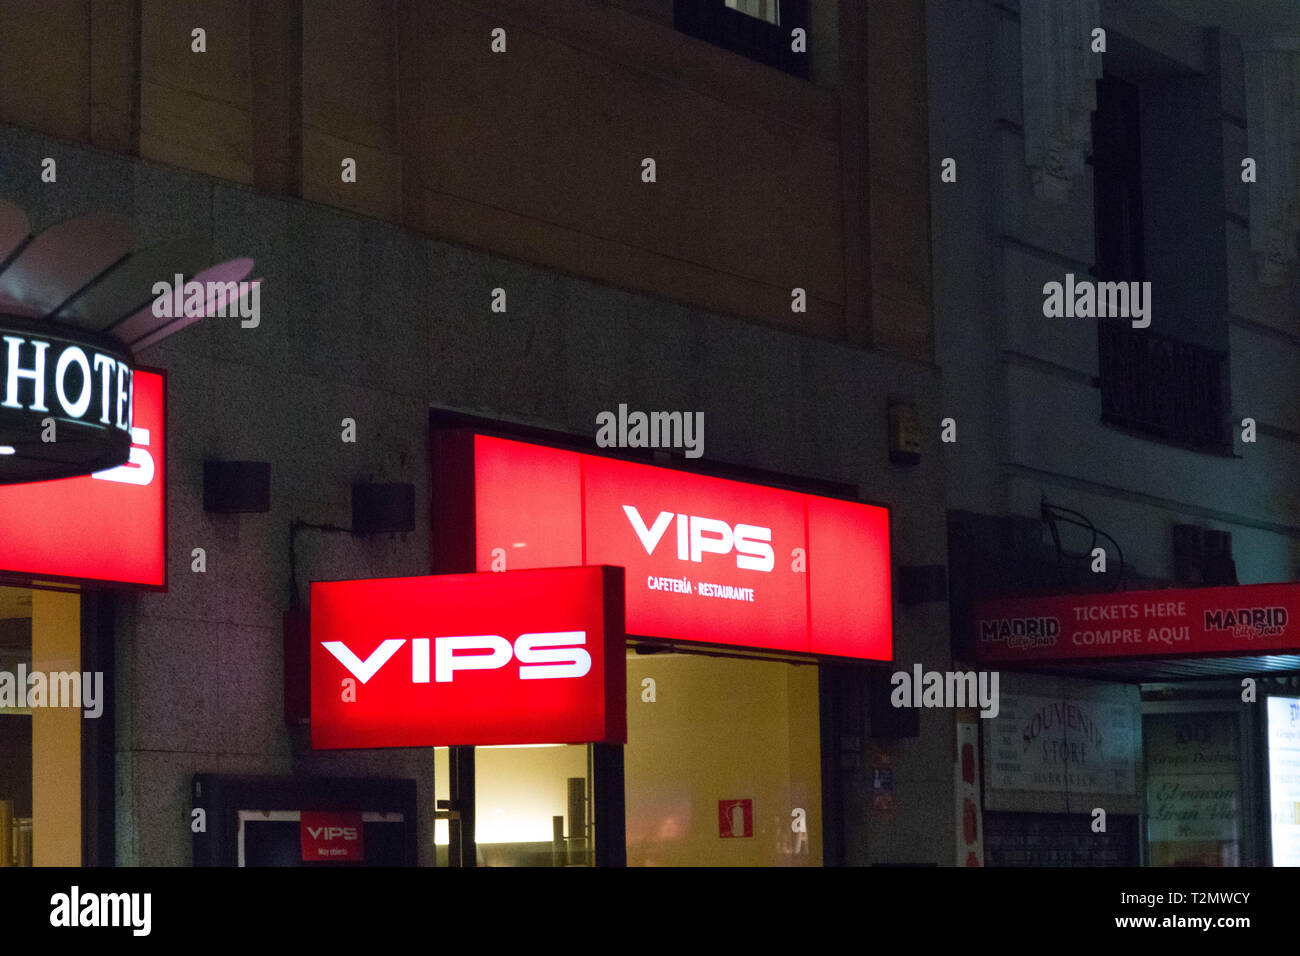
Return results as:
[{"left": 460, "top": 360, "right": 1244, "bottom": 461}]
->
[{"left": 0, "top": 119, "right": 952, "bottom": 865}]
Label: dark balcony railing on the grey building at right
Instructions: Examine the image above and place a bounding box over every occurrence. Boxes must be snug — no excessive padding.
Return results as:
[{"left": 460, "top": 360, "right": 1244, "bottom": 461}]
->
[{"left": 1097, "top": 320, "right": 1232, "bottom": 455}]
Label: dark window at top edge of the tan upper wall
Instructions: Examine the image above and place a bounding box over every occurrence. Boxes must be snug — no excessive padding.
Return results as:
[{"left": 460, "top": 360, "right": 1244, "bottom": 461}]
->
[{"left": 672, "top": 0, "right": 809, "bottom": 79}]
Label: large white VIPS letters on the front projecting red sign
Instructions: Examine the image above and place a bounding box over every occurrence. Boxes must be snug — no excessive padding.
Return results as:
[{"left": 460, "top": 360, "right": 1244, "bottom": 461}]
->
[{"left": 321, "top": 631, "right": 592, "bottom": 684}]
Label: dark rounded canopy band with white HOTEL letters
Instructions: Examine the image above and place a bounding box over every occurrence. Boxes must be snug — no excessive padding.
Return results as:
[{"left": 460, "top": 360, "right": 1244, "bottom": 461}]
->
[{"left": 0, "top": 317, "right": 134, "bottom": 484}]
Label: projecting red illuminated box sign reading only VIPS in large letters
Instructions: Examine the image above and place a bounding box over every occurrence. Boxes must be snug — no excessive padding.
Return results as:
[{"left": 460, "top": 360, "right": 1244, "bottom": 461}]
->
[{"left": 311, "top": 567, "right": 627, "bottom": 749}]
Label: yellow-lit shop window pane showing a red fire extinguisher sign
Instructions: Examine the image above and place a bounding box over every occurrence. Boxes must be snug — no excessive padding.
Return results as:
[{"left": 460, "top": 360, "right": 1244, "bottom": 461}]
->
[{"left": 624, "top": 653, "right": 822, "bottom": 866}]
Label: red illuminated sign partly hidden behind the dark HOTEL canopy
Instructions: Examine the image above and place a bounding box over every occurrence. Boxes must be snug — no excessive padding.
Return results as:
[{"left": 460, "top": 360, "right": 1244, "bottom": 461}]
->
[{"left": 0, "top": 369, "right": 166, "bottom": 588}]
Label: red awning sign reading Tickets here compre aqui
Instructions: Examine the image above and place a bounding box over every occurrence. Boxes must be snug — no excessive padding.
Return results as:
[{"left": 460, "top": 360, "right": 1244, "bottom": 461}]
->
[{"left": 974, "top": 584, "right": 1300, "bottom": 663}]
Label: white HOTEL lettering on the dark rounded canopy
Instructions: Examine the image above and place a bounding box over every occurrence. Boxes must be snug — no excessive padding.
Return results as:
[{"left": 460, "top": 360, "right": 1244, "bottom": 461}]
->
[{"left": 0, "top": 334, "right": 134, "bottom": 432}]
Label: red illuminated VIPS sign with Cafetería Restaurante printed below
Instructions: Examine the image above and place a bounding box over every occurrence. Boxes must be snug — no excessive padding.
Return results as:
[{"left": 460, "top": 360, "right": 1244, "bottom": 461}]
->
[{"left": 433, "top": 431, "right": 892, "bottom": 661}]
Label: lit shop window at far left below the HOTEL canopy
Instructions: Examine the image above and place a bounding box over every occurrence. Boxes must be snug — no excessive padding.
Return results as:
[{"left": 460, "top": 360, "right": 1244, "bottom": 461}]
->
[{"left": 0, "top": 588, "right": 81, "bottom": 866}]
